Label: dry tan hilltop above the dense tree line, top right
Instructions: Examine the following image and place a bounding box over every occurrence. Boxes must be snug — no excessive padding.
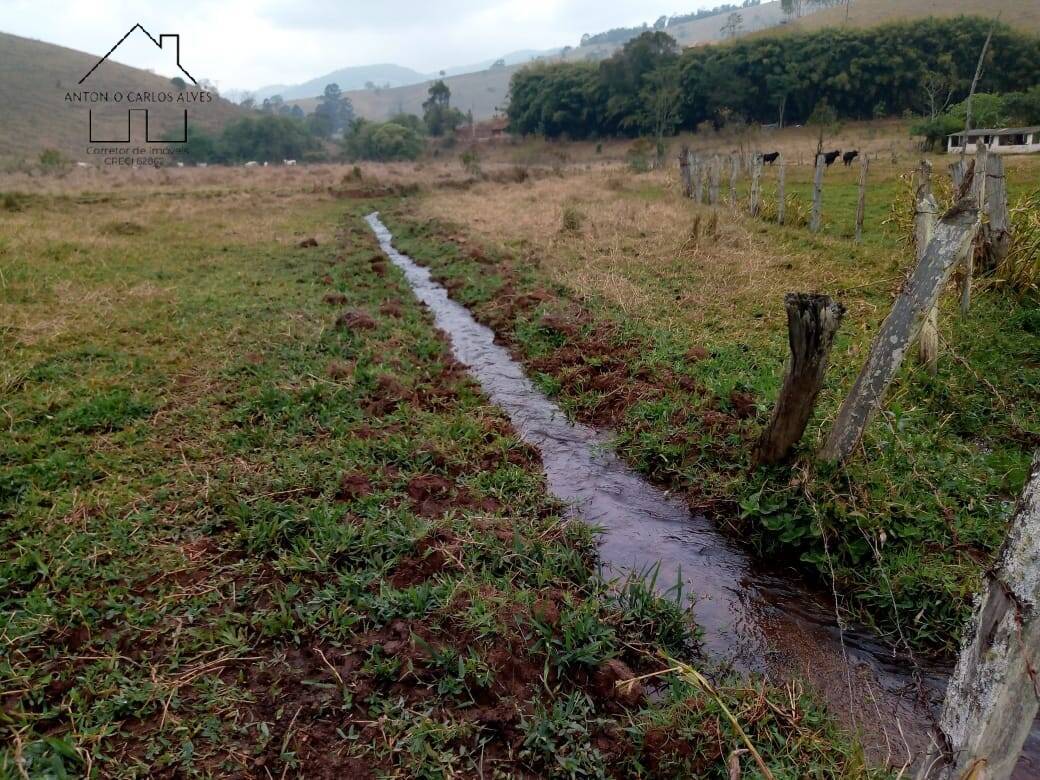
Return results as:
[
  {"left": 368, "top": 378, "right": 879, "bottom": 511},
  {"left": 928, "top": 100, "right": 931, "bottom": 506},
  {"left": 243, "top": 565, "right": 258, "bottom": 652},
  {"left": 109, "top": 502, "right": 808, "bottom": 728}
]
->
[{"left": 757, "top": 0, "right": 1040, "bottom": 34}]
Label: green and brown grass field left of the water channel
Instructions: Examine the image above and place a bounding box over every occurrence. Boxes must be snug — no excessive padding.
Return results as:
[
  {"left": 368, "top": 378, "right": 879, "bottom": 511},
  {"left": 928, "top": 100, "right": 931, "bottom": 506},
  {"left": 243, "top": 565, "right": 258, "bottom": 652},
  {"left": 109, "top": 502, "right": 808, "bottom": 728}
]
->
[{"left": 0, "top": 173, "right": 876, "bottom": 778}]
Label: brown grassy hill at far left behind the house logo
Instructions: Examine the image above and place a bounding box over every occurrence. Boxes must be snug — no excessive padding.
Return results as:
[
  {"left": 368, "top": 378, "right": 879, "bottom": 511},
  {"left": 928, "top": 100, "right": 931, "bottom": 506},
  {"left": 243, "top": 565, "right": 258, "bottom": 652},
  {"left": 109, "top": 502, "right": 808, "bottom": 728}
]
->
[{"left": 0, "top": 32, "right": 244, "bottom": 160}]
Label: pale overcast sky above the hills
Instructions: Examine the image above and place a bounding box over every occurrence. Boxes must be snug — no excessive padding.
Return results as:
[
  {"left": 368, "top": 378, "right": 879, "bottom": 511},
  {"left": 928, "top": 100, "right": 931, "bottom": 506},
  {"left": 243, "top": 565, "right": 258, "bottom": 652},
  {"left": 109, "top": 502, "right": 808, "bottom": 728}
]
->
[{"left": 0, "top": 0, "right": 719, "bottom": 89}]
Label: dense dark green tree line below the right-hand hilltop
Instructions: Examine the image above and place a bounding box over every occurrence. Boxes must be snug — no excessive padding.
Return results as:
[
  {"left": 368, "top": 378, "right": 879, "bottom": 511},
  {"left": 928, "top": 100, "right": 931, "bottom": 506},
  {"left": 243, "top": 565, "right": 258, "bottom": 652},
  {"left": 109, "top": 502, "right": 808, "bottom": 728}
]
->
[{"left": 509, "top": 17, "right": 1040, "bottom": 138}]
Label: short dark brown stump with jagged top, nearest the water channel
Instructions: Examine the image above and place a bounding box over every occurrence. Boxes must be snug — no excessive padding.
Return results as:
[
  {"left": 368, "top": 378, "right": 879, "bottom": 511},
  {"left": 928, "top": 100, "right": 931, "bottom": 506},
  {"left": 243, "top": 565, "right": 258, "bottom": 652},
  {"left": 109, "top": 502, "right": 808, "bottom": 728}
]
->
[{"left": 752, "top": 292, "right": 846, "bottom": 466}]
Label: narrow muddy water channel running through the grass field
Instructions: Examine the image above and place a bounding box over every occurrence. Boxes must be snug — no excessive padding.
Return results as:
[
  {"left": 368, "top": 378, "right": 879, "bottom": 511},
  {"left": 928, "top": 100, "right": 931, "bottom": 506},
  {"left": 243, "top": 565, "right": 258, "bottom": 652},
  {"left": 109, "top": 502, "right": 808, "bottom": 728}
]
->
[{"left": 366, "top": 214, "right": 1040, "bottom": 778}]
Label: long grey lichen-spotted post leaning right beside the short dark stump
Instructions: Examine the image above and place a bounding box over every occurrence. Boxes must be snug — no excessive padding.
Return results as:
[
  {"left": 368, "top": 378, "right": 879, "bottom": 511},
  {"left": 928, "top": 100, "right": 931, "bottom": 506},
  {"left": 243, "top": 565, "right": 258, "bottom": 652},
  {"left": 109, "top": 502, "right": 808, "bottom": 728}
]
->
[{"left": 820, "top": 179, "right": 979, "bottom": 461}]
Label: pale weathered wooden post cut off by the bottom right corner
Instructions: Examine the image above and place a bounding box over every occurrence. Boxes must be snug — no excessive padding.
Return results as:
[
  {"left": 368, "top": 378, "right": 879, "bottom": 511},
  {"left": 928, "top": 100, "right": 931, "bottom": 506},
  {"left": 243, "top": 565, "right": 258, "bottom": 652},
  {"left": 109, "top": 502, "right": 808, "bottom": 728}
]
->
[{"left": 917, "top": 451, "right": 1040, "bottom": 780}]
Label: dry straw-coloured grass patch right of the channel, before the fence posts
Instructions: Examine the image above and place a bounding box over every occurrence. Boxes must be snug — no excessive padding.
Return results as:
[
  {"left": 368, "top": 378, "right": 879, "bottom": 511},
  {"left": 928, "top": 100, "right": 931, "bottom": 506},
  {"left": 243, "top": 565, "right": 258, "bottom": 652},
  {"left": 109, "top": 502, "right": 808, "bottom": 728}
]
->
[{"left": 421, "top": 172, "right": 886, "bottom": 343}]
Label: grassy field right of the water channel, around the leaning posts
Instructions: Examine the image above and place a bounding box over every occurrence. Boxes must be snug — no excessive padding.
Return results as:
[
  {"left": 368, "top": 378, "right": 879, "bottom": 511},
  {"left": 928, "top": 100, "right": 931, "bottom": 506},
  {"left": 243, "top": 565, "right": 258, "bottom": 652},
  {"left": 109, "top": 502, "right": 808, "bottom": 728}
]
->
[{"left": 394, "top": 149, "right": 1040, "bottom": 654}]
